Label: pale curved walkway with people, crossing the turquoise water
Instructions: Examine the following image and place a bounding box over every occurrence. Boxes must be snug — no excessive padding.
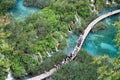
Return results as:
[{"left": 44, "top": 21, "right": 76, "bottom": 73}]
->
[{"left": 28, "top": 10, "right": 120, "bottom": 80}]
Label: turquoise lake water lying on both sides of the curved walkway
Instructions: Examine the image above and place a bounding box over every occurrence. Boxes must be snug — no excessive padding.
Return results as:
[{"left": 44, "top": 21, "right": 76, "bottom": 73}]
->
[{"left": 66, "top": 9, "right": 118, "bottom": 57}]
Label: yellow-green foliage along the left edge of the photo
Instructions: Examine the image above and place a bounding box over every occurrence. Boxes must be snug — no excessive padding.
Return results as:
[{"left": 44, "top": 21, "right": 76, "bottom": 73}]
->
[{"left": 0, "top": 19, "right": 12, "bottom": 80}]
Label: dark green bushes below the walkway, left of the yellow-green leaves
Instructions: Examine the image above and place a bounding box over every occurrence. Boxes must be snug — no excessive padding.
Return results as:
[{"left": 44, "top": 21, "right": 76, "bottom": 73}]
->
[{"left": 51, "top": 50, "right": 98, "bottom": 80}]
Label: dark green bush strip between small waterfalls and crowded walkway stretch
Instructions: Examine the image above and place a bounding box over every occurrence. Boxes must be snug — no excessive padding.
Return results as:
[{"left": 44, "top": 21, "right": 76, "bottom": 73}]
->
[{"left": 37, "top": 52, "right": 67, "bottom": 74}]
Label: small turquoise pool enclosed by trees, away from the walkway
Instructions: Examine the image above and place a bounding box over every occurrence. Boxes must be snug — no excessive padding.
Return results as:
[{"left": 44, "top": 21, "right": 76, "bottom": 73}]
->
[{"left": 8, "top": 0, "right": 40, "bottom": 18}]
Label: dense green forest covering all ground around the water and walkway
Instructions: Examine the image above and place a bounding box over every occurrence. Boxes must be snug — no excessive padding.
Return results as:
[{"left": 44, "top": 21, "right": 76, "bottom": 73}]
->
[{"left": 0, "top": 0, "right": 120, "bottom": 80}]
